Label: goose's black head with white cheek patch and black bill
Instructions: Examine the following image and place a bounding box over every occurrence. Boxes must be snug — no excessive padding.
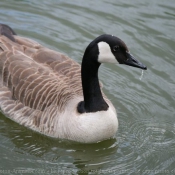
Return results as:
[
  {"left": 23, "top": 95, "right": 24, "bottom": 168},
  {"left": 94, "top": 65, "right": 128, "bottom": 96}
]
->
[{"left": 88, "top": 34, "right": 147, "bottom": 70}]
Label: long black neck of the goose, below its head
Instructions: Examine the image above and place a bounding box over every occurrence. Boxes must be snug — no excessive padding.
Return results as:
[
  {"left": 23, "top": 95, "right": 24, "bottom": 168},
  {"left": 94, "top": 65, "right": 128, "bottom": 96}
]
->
[{"left": 78, "top": 47, "right": 108, "bottom": 113}]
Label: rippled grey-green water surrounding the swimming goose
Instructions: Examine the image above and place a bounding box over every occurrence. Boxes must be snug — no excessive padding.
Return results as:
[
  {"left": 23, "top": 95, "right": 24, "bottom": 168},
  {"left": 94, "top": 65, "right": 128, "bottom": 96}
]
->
[{"left": 0, "top": 0, "right": 175, "bottom": 175}]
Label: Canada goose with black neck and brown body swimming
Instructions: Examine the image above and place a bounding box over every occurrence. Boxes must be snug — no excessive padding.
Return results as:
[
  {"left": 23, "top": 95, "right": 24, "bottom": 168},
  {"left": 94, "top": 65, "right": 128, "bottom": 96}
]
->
[{"left": 0, "top": 24, "right": 147, "bottom": 143}]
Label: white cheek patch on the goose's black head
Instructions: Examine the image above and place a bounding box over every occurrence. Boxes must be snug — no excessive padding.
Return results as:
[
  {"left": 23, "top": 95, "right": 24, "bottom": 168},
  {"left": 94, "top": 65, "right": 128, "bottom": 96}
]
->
[{"left": 98, "top": 41, "right": 118, "bottom": 64}]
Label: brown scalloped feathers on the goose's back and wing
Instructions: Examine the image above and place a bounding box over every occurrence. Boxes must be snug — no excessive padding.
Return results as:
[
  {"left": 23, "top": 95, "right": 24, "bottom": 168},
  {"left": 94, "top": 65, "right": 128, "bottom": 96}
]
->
[{"left": 0, "top": 36, "right": 85, "bottom": 131}]
